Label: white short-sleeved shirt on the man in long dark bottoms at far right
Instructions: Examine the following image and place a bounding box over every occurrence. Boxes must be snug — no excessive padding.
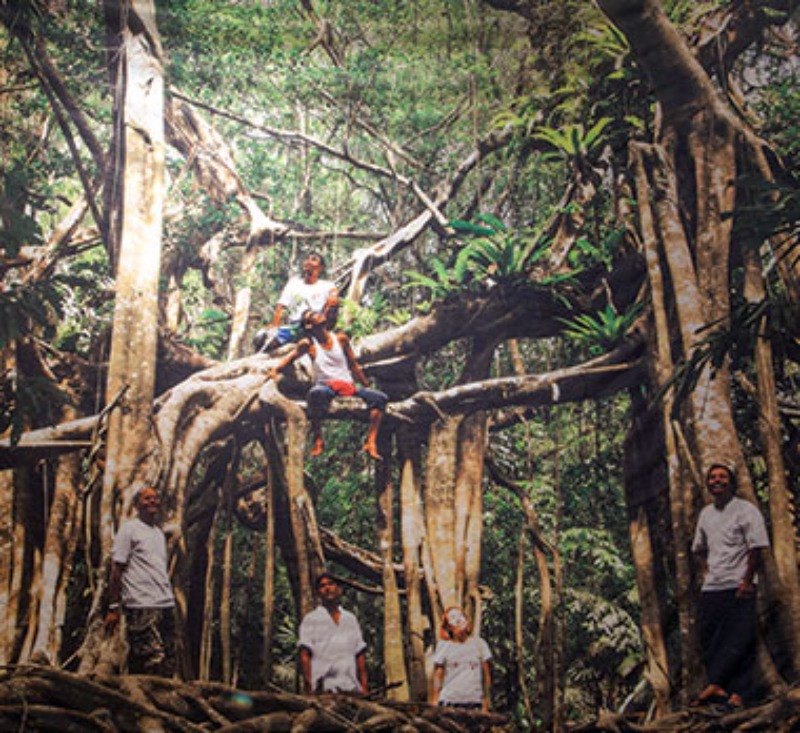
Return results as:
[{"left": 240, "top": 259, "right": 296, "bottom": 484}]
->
[{"left": 692, "top": 496, "right": 769, "bottom": 591}]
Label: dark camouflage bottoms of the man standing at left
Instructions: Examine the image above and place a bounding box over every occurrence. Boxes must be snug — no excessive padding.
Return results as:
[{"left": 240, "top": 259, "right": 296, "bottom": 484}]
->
[{"left": 125, "top": 608, "right": 175, "bottom": 677}]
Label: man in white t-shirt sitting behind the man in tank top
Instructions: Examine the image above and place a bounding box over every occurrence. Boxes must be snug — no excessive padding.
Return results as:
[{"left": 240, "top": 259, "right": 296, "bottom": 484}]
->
[{"left": 253, "top": 252, "right": 339, "bottom": 352}]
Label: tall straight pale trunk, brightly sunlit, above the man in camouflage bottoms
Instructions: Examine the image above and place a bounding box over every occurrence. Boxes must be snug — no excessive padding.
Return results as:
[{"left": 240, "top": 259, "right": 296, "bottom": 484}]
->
[{"left": 101, "top": 0, "right": 165, "bottom": 557}]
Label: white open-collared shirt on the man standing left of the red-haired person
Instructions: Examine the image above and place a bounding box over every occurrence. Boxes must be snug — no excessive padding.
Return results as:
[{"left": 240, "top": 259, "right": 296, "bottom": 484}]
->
[{"left": 297, "top": 606, "right": 367, "bottom": 692}]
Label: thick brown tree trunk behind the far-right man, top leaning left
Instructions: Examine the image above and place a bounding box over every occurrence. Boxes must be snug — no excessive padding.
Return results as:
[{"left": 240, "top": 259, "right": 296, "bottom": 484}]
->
[{"left": 599, "top": 0, "right": 796, "bottom": 691}]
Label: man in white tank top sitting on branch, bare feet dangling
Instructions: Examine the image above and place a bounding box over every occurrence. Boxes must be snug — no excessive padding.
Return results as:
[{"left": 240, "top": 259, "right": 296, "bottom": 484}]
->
[{"left": 271, "top": 310, "right": 389, "bottom": 460}]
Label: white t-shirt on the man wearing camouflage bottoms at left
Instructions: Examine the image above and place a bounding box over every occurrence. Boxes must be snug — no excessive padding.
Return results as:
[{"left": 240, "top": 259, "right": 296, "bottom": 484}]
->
[{"left": 112, "top": 517, "right": 175, "bottom": 608}]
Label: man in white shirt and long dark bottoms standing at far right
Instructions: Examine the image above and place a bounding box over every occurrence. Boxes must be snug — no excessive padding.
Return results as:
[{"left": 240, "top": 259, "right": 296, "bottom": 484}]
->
[{"left": 692, "top": 464, "right": 769, "bottom": 707}]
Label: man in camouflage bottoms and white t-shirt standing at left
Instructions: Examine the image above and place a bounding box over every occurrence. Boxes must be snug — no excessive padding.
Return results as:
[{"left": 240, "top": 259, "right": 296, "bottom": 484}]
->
[{"left": 105, "top": 487, "right": 175, "bottom": 677}]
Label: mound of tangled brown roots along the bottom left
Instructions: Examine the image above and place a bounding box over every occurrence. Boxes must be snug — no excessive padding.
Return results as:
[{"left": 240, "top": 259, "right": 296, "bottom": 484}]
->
[{"left": 0, "top": 665, "right": 513, "bottom": 733}]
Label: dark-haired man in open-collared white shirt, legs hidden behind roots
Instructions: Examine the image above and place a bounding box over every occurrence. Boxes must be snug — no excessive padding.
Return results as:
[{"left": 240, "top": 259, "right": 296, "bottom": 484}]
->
[{"left": 298, "top": 573, "right": 368, "bottom": 695}]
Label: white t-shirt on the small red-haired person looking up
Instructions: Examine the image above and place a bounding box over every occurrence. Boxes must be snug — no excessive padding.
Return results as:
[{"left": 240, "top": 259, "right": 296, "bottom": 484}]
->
[{"left": 433, "top": 636, "right": 492, "bottom": 704}]
